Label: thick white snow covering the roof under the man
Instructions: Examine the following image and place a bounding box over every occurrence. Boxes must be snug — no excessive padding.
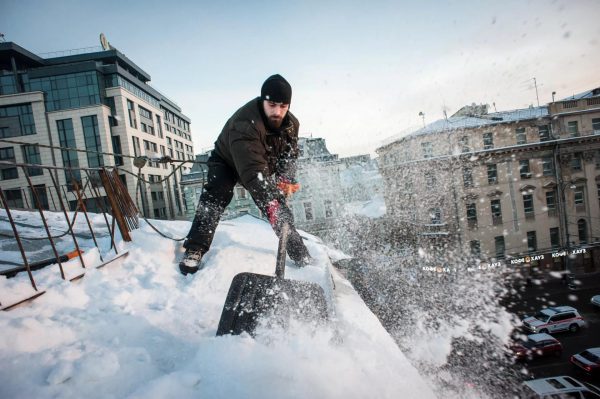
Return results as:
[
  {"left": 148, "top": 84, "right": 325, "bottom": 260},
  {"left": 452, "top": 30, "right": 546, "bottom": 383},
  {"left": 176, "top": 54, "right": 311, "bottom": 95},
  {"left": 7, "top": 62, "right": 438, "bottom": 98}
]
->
[{"left": 0, "top": 214, "right": 434, "bottom": 398}]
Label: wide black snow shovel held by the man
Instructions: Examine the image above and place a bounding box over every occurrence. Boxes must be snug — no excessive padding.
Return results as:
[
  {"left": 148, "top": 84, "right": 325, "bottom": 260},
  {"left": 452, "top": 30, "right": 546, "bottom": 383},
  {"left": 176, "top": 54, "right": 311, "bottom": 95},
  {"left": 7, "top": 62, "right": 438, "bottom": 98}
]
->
[{"left": 217, "top": 223, "right": 327, "bottom": 336}]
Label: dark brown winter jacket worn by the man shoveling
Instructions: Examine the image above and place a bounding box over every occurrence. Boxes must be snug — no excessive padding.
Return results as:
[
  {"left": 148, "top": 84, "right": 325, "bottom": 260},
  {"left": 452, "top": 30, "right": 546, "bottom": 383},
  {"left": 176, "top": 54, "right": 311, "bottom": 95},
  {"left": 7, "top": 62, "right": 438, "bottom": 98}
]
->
[{"left": 215, "top": 97, "right": 300, "bottom": 206}]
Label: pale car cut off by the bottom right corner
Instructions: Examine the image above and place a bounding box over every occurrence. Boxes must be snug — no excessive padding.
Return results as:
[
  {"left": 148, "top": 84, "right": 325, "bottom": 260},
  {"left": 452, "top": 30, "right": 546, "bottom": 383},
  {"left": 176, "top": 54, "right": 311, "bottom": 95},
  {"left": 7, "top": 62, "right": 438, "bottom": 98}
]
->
[{"left": 521, "top": 376, "right": 600, "bottom": 399}]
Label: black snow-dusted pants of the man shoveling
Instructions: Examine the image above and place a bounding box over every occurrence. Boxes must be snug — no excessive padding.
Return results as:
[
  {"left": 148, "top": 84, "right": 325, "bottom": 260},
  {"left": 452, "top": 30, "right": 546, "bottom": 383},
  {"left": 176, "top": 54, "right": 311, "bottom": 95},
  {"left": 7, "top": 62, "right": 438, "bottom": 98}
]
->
[{"left": 183, "top": 153, "right": 310, "bottom": 262}]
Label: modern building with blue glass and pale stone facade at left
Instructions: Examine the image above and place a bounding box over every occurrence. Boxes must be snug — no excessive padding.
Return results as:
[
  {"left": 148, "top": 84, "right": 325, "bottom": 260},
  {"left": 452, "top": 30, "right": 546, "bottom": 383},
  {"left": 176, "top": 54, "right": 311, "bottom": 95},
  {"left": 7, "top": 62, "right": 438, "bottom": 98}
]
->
[{"left": 0, "top": 42, "right": 194, "bottom": 219}]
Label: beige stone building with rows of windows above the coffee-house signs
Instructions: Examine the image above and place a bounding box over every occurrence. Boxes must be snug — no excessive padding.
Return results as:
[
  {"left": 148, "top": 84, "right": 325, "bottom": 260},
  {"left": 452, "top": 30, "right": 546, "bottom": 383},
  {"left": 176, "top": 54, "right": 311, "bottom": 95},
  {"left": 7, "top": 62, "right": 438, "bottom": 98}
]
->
[{"left": 377, "top": 89, "right": 600, "bottom": 271}]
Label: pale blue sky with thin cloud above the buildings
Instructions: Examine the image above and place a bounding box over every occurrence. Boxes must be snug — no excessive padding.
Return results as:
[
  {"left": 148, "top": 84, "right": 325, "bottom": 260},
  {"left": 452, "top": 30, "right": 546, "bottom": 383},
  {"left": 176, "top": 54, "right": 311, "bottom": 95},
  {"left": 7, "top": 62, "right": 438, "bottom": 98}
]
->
[{"left": 0, "top": 0, "right": 600, "bottom": 156}]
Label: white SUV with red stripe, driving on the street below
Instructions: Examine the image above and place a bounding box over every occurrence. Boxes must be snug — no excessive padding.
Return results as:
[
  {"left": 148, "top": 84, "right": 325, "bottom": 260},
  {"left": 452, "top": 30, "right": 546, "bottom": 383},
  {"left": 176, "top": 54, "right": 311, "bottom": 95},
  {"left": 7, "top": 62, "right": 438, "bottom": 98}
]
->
[{"left": 523, "top": 306, "right": 585, "bottom": 334}]
